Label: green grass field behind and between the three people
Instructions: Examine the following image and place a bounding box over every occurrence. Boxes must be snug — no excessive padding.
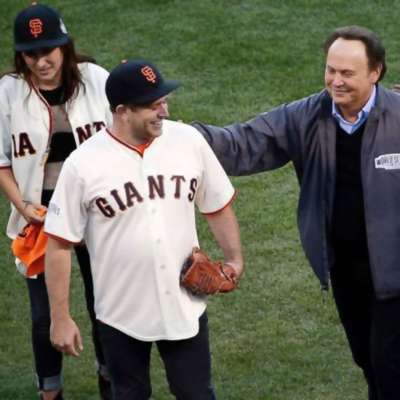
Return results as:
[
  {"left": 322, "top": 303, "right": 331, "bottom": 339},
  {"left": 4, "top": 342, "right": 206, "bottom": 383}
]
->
[{"left": 0, "top": 0, "right": 400, "bottom": 400}]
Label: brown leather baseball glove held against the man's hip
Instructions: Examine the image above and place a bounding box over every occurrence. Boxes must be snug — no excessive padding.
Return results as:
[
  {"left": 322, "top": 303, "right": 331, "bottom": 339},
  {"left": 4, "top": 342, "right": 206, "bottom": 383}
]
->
[{"left": 181, "top": 247, "right": 238, "bottom": 295}]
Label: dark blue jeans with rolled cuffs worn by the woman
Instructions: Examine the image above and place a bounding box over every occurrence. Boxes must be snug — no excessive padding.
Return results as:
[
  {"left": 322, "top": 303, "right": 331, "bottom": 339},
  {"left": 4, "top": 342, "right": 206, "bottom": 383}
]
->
[{"left": 26, "top": 246, "right": 104, "bottom": 391}]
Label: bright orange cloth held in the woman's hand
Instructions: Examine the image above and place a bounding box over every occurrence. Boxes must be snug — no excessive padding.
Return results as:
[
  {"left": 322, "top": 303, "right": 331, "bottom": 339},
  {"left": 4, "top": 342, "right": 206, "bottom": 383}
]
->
[{"left": 11, "top": 209, "right": 47, "bottom": 277}]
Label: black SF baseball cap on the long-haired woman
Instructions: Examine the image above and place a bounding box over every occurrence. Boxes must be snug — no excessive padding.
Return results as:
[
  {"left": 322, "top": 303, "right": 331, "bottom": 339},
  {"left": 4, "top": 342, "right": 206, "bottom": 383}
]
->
[{"left": 14, "top": 3, "right": 70, "bottom": 51}]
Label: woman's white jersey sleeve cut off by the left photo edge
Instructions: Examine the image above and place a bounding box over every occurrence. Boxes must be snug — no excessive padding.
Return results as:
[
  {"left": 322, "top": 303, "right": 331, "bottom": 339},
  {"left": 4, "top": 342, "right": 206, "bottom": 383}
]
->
[{"left": 0, "top": 78, "right": 11, "bottom": 168}]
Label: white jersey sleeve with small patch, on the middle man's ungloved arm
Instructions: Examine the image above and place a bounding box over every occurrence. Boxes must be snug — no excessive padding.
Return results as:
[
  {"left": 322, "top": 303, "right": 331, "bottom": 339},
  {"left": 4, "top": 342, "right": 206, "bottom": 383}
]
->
[{"left": 44, "top": 157, "right": 87, "bottom": 243}]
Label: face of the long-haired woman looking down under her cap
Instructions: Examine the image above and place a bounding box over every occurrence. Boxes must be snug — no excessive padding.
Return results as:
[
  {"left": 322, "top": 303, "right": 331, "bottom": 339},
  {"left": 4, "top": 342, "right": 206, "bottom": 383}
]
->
[{"left": 22, "top": 47, "right": 64, "bottom": 90}]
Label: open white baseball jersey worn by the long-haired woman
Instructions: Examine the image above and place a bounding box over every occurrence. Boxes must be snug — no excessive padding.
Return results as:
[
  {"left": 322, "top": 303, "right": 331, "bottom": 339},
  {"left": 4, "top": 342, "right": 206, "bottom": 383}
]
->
[{"left": 0, "top": 63, "right": 112, "bottom": 239}]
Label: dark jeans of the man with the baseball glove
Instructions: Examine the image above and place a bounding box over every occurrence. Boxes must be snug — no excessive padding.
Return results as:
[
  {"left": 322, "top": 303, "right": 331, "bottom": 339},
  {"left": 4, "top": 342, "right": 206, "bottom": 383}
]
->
[{"left": 98, "top": 313, "right": 216, "bottom": 400}]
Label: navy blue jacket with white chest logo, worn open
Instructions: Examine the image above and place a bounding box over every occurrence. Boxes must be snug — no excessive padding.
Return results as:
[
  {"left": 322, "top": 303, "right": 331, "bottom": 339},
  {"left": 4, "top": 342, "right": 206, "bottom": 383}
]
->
[{"left": 193, "top": 86, "right": 400, "bottom": 299}]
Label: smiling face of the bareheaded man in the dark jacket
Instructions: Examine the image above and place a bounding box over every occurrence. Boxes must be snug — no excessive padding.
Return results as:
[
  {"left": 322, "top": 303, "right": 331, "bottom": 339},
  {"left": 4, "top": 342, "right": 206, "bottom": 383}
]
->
[{"left": 325, "top": 38, "right": 381, "bottom": 121}]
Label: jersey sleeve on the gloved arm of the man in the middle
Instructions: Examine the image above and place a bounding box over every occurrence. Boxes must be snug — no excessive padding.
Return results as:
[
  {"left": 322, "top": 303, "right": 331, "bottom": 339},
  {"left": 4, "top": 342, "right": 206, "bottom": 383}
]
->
[{"left": 195, "top": 132, "right": 235, "bottom": 214}]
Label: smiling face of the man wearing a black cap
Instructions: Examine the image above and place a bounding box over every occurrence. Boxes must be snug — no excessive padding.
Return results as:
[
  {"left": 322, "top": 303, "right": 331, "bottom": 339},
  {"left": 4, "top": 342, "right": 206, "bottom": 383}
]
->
[{"left": 118, "top": 96, "right": 169, "bottom": 144}]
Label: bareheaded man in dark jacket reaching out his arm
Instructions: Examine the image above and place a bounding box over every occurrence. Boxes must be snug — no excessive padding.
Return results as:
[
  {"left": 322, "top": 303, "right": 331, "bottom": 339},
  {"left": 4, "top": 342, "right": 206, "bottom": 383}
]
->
[{"left": 194, "top": 26, "right": 400, "bottom": 400}]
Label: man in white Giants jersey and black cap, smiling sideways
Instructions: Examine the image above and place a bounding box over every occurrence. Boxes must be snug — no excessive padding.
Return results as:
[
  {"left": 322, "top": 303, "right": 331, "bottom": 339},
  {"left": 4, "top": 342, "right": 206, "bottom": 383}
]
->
[{"left": 45, "top": 60, "right": 243, "bottom": 400}]
